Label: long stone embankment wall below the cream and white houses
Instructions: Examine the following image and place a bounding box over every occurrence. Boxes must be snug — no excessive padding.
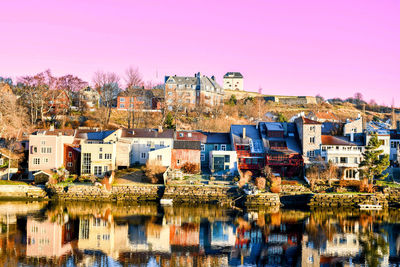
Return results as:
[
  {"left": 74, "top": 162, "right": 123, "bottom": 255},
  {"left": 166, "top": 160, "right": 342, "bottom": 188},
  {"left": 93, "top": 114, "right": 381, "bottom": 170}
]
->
[{"left": 47, "top": 184, "right": 163, "bottom": 202}]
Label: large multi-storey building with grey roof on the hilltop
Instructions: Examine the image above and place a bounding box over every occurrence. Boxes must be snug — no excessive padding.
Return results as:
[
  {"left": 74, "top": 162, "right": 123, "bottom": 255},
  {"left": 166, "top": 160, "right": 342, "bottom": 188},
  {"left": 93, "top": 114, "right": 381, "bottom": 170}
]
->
[{"left": 165, "top": 72, "right": 224, "bottom": 110}]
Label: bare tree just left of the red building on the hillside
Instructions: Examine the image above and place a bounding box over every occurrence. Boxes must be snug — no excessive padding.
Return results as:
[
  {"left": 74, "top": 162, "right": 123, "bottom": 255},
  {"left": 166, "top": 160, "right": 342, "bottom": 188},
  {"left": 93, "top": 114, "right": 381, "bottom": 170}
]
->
[{"left": 93, "top": 71, "right": 120, "bottom": 126}]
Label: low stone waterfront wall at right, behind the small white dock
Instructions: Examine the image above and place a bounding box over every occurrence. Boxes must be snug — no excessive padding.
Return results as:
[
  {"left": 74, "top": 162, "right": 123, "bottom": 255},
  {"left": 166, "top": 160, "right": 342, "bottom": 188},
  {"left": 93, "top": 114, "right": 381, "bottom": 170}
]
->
[{"left": 309, "top": 193, "right": 388, "bottom": 208}]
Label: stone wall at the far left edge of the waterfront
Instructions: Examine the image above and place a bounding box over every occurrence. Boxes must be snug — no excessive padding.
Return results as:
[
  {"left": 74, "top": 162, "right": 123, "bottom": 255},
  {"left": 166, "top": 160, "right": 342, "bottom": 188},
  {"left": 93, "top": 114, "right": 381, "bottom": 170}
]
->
[{"left": 0, "top": 185, "right": 47, "bottom": 200}]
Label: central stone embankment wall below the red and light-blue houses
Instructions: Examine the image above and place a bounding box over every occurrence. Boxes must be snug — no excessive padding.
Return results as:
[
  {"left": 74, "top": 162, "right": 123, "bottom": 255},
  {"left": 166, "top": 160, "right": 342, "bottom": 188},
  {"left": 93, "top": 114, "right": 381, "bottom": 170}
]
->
[{"left": 163, "top": 185, "right": 239, "bottom": 204}]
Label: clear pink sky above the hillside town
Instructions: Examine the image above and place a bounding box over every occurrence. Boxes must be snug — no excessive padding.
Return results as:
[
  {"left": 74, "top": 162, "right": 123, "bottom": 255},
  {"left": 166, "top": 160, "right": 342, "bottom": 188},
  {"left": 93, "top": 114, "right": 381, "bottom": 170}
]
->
[{"left": 0, "top": 0, "right": 400, "bottom": 106}]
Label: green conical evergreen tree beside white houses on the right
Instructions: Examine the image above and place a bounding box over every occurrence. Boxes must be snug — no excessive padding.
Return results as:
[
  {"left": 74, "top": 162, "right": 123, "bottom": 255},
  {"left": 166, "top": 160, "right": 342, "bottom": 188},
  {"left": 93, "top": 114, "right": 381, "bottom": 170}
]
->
[{"left": 360, "top": 133, "right": 390, "bottom": 183}]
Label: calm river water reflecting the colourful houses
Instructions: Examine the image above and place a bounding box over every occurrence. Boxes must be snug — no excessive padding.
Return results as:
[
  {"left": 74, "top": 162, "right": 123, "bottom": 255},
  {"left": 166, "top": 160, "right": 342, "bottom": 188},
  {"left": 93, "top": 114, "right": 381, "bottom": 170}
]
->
[{"left": 0, "top": 202, "right": 400, "bottom": 266}]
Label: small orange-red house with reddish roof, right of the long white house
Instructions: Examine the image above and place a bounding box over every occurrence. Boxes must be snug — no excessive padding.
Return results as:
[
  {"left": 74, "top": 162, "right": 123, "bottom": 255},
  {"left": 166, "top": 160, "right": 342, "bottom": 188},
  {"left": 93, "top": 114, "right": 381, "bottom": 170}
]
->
[{"left": 171, "top": 140, "right": 201, "bottom": 170}]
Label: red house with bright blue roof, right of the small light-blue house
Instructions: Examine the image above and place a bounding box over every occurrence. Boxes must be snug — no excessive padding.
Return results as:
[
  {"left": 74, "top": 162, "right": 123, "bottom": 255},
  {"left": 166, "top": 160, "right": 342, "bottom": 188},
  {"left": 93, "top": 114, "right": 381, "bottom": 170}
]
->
[{"left": 230, "top": 125, "right": 265, "bottom": 170}]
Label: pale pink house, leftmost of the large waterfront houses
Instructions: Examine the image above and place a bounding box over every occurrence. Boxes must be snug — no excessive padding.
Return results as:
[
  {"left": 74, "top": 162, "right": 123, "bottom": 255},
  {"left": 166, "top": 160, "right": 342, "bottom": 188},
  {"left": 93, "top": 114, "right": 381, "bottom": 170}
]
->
[{"left": 28, "top": 128, "right": 75, "bottom": 179}]
